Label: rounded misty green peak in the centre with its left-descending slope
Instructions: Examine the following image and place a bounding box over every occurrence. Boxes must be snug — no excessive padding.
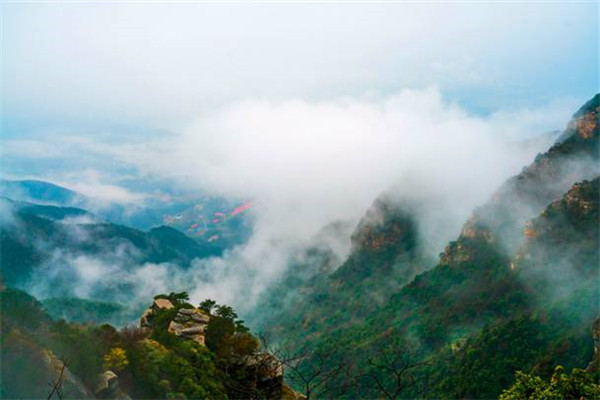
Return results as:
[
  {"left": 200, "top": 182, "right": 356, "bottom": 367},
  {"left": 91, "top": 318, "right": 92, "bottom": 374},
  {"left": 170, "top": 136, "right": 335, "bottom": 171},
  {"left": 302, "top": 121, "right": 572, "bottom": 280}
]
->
[{"left": 251, "top": 196, "right": 433, "bottom": 339}]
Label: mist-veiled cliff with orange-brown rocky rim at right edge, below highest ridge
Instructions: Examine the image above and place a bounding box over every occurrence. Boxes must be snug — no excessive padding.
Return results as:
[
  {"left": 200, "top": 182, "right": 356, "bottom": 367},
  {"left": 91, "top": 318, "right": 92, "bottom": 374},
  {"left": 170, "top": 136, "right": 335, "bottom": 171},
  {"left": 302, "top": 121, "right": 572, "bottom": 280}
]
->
[{"left": 511, "top": 178, "right": 600, "bottom": 310}]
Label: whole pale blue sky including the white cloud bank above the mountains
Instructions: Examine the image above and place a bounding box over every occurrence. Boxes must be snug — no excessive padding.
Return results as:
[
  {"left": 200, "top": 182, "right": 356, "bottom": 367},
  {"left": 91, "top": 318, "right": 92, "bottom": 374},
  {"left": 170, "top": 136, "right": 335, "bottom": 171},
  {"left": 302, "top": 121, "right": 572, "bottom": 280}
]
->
[{"left": 0, "top": 1, "right": 598, "bottom": 308}]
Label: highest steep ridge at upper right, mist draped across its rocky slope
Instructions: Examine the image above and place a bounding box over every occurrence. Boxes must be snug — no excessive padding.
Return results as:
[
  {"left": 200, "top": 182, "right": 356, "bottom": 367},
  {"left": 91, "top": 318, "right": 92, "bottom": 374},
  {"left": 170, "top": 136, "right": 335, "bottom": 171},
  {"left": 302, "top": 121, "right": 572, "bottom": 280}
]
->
[{"left": 441, "top": 95, "right": 600, "bottom": 265}]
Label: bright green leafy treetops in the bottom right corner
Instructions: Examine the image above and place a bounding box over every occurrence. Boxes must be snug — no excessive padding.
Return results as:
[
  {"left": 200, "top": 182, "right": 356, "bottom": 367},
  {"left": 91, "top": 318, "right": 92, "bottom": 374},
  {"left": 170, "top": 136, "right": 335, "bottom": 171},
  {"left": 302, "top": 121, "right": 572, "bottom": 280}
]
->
[{"left": 500, "top": 366, "right": 600, "bottom": 400}]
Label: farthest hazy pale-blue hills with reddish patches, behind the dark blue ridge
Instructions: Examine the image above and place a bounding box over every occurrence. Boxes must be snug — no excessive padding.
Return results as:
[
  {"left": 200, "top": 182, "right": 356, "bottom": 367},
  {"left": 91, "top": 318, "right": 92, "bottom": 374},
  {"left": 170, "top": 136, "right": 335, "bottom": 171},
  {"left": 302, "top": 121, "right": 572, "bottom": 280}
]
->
[{"left": 0, "top": 180, "right": 252, "bottom": 247}]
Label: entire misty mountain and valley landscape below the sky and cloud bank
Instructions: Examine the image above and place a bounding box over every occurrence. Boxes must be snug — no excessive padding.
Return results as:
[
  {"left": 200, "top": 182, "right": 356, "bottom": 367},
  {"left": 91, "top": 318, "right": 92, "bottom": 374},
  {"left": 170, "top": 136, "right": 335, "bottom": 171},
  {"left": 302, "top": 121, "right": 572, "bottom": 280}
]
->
[{"left": 0, "top": 95, "right": 600, "bottom": 400}]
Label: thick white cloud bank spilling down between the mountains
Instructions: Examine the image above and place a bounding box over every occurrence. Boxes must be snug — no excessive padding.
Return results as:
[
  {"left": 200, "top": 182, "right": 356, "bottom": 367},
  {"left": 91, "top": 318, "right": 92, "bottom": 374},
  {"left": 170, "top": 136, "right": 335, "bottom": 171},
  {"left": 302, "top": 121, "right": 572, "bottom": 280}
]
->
[{"left": 5, "top": 88, "right": 584, "bottom": 312}]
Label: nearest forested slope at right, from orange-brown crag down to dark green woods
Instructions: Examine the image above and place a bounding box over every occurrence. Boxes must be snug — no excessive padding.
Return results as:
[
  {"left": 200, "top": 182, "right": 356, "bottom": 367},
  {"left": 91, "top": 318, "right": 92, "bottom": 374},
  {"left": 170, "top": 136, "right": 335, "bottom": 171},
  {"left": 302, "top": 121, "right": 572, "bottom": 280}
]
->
[{"left": 427, "top": 178, "right": 600, "bottom": 398}]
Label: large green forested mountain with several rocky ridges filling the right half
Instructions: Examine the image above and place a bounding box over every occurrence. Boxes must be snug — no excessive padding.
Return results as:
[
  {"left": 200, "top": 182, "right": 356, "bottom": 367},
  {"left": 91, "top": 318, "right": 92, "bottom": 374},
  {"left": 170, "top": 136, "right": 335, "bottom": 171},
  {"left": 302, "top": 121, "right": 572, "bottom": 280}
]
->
[{"left": 257, "top": 95, "right": 600, "bottom": 398}]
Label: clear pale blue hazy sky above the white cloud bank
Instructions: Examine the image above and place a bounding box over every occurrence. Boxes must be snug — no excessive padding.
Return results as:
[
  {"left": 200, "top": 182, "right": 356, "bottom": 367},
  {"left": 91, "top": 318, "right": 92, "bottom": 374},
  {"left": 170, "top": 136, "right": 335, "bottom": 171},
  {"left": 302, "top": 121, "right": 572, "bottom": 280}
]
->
[{"left": 2, "top": 2, "right": 598, "bottom": 130}]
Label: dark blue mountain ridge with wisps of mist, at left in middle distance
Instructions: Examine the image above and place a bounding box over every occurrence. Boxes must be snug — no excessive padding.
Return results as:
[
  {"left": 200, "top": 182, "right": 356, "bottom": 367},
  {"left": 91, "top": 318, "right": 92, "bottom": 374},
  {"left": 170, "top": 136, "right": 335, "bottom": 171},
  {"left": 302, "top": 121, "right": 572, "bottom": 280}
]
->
[{"left": 0, "top": 200, "right": 221, "bottom": 295}]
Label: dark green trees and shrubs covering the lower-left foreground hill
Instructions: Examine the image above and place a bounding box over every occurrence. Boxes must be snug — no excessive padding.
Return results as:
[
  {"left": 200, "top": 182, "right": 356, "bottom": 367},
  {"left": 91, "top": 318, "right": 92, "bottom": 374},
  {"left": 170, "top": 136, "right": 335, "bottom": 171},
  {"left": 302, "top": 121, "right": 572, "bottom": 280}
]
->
[{"left": 0, "top": 289, "right": 282, "bottom": 399}]
